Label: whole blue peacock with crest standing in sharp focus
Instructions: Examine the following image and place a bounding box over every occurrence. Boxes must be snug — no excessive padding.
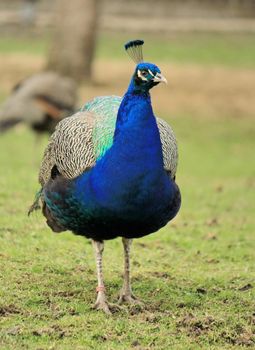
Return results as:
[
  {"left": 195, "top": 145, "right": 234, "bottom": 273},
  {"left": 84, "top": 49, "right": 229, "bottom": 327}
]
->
[{"left": 29, "top": 40, "right": 181, "bottom": 314}]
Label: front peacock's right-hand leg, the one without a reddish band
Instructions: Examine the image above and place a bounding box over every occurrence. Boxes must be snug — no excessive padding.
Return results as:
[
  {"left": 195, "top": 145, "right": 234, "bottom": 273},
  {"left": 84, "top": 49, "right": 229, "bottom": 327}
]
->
[{"left": 119, "top": 237, "right": 141, "bottom": 304}]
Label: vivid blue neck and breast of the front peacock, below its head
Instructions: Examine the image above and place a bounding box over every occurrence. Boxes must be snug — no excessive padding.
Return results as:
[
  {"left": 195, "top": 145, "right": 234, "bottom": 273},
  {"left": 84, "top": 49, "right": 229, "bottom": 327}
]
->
[{"left": 74, "top": 80, "right": 168, "bottom": 207}]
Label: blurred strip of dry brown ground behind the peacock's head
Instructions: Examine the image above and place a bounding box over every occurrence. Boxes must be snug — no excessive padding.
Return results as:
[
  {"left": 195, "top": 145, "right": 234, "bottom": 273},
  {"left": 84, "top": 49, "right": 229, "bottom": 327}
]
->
[{"left": 0, "top": 54, "right": 255, "bottom": 118}]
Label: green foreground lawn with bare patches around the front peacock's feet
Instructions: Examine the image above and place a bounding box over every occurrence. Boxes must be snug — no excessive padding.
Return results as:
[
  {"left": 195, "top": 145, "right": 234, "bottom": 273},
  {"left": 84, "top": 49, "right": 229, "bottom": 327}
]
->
[{"left": 0, "top": 116, "right": 255, "bottom": 350}]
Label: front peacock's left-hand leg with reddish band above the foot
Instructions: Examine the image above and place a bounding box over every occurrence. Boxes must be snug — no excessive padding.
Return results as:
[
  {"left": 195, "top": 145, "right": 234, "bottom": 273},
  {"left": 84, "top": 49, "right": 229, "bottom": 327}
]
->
[{"left": 92, "top": 240, "right": 111, "bottom": 314}]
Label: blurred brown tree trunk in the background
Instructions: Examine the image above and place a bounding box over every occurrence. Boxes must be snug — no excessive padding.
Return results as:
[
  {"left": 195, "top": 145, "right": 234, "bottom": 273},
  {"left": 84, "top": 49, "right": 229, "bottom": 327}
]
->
[{"left": 47, "top": 0, "right": 99, "bottom": 82}]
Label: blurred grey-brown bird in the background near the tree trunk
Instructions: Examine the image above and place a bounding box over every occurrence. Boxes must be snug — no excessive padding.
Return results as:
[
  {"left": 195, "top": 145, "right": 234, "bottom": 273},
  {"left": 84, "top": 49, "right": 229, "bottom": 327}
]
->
[{"left": 0, "top": 71, "right": 77, "bottom": 134}]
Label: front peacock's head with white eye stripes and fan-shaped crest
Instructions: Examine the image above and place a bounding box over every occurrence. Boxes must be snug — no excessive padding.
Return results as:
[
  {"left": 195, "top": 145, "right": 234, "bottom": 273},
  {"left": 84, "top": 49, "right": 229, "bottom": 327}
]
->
[{"left": 125, "top": 40, "right": 167, "bottom": 92}]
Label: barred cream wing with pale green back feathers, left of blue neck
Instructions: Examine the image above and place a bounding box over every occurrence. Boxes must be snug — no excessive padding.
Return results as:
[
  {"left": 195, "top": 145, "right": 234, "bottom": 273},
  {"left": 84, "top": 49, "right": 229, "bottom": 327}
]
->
[{"left": 39, "top": 96, "right": 121, "bottom": 186}]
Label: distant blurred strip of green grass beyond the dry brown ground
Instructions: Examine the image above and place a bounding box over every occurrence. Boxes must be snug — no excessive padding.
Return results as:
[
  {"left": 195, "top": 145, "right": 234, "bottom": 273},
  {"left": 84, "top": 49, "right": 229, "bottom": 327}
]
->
[{"left": 0, "top": 33, "right": 255, "bottom": 68}]
